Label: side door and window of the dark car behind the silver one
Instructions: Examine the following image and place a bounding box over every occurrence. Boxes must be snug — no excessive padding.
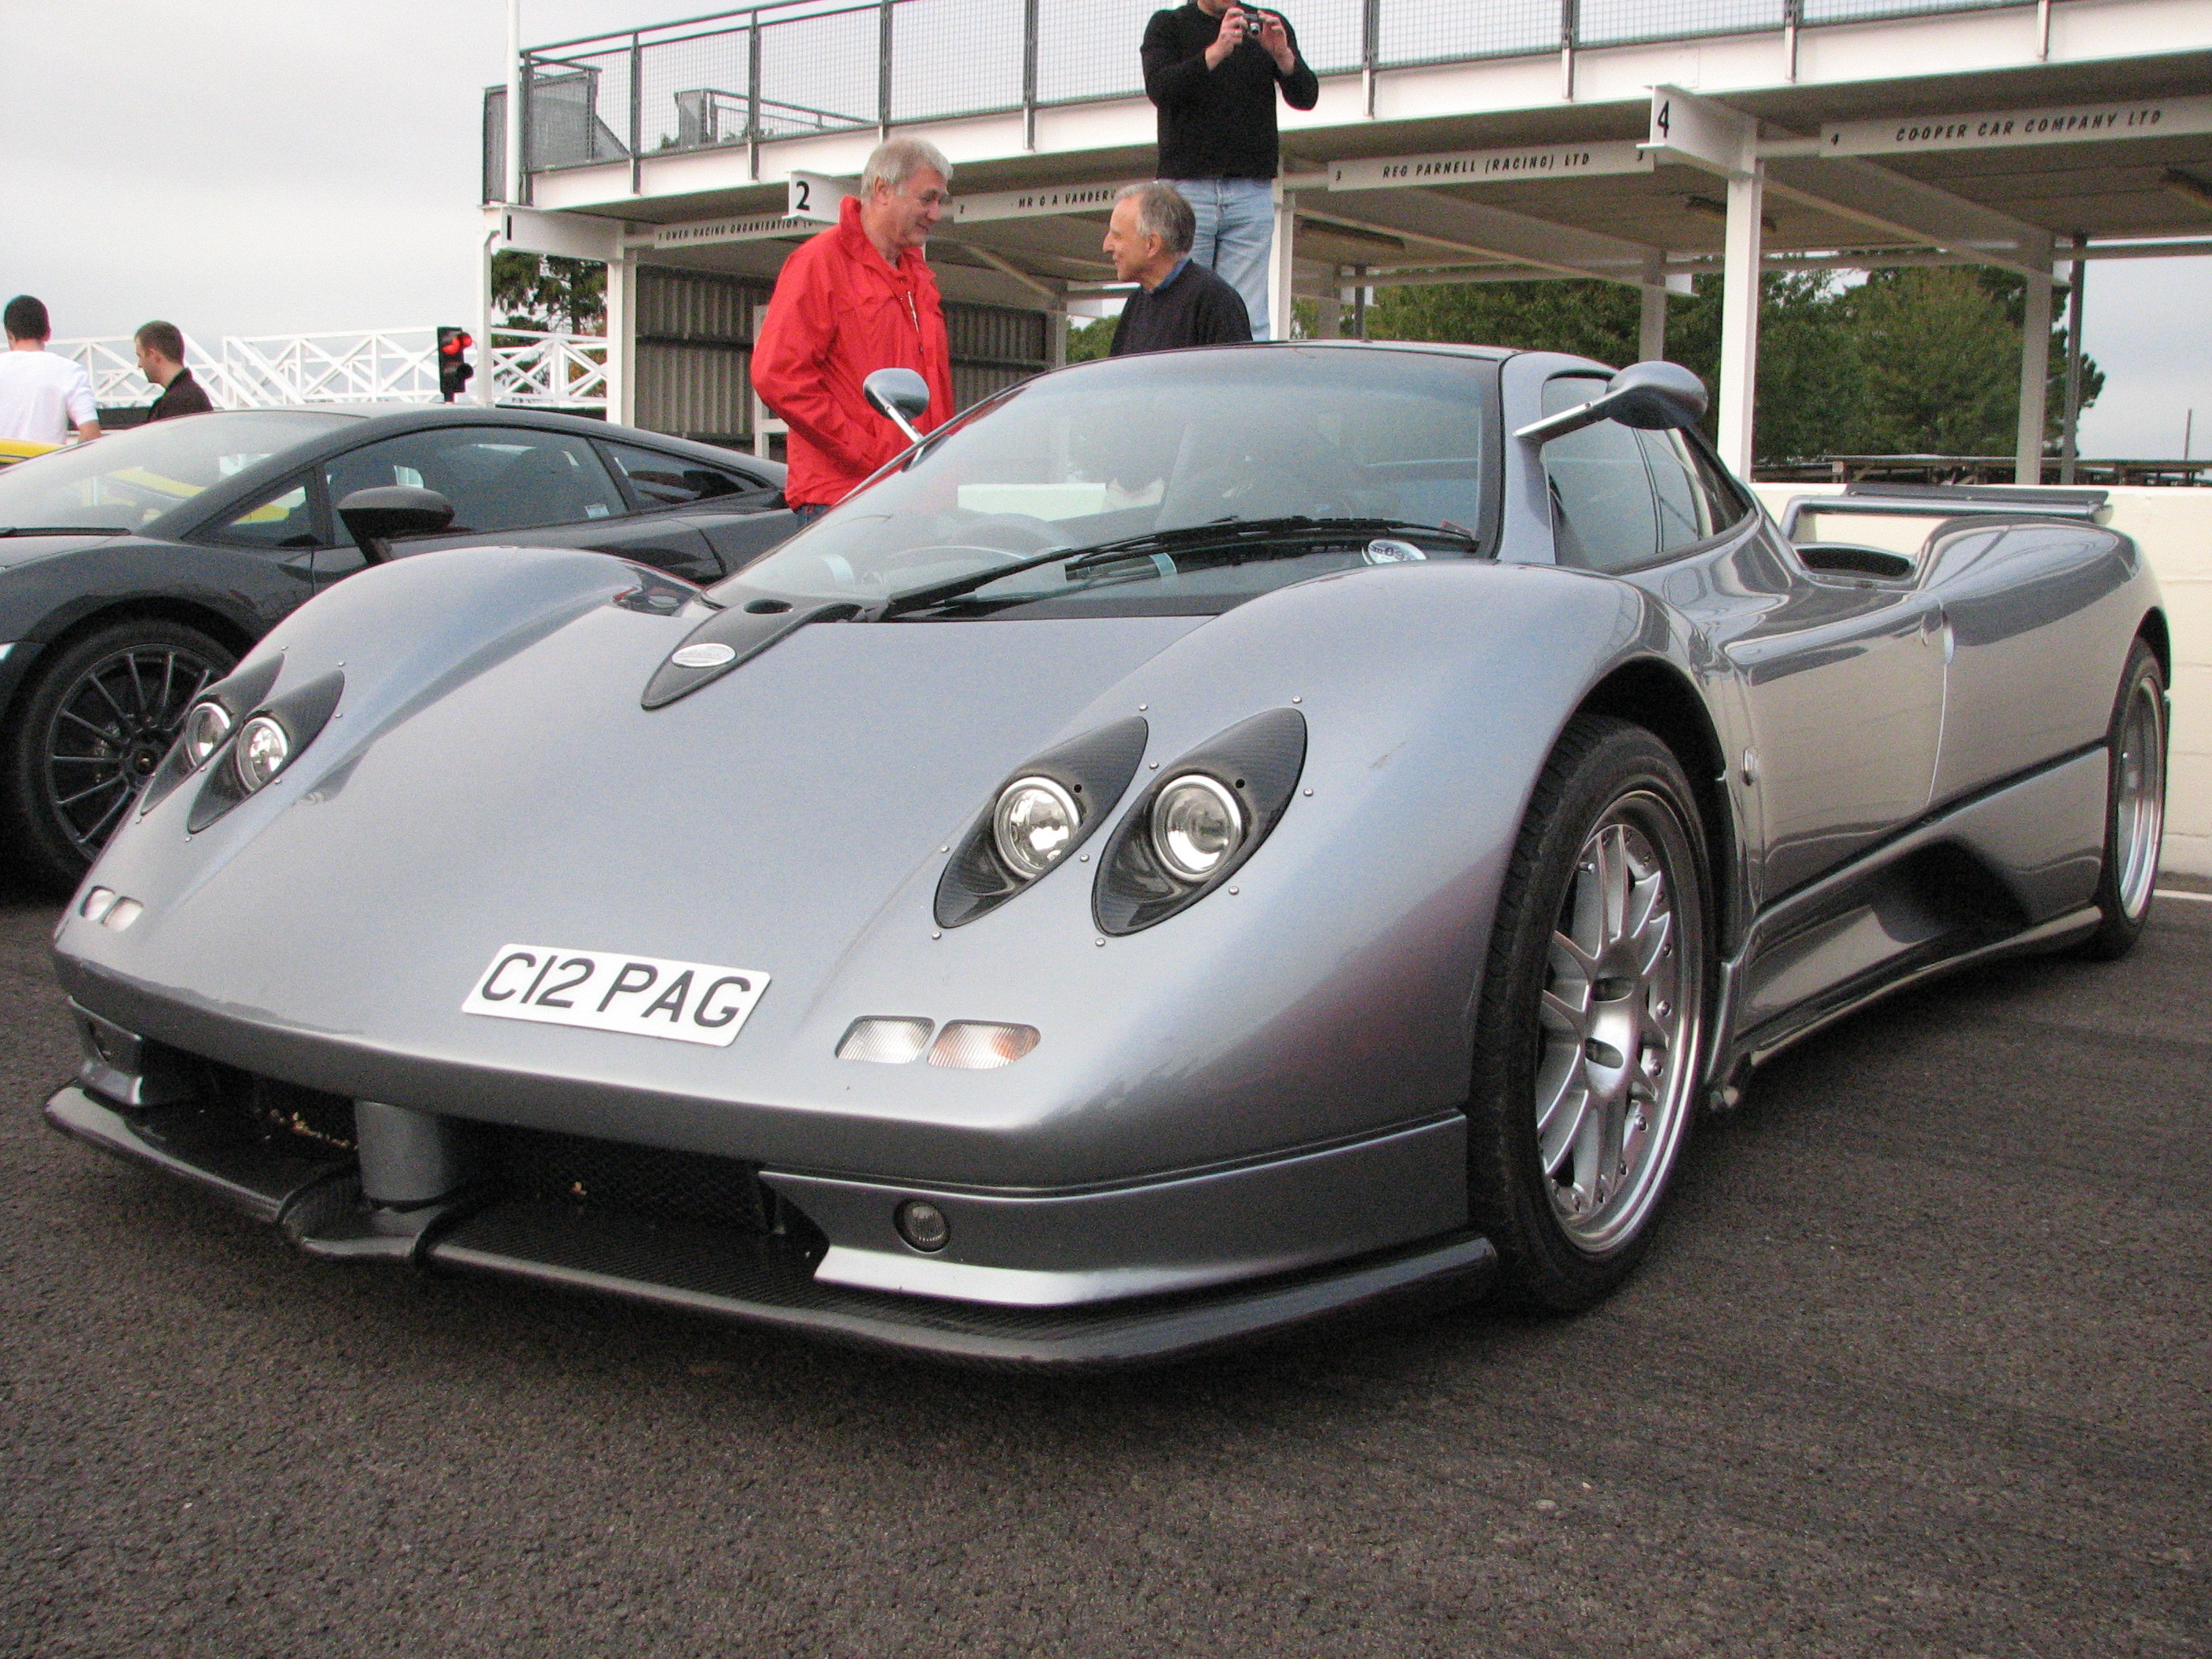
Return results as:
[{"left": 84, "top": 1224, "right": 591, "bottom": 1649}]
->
[{"left": 317, "top": 423, "right": 721, "bottom": 586}]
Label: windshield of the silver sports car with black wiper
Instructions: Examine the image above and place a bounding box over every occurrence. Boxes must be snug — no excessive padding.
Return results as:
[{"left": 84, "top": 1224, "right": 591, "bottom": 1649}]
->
[{"left": 732, "top": 347, "right": 1496, "bottom": 617}]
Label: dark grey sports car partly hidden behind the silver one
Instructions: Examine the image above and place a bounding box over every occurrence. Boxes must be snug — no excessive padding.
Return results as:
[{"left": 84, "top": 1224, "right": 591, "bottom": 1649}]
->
[{"left": 0, "top": 405, "right": 792, "bottom": 887}]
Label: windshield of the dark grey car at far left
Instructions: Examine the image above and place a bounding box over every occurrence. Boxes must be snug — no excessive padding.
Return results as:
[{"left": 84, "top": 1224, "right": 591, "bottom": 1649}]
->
[{"left": 0, "top": 409, "right": 358, "bottom": 531}]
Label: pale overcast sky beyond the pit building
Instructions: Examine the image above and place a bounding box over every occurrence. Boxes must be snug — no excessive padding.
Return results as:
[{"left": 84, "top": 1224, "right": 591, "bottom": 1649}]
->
[{"left": 0, "top": 0, "right": 2212, "bottom": 456}]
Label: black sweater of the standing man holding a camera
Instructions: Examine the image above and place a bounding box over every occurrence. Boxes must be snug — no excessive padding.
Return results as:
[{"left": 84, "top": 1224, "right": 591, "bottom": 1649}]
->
[{"left": 1144, "top": 5, "right": 1320, "bottom": 179}]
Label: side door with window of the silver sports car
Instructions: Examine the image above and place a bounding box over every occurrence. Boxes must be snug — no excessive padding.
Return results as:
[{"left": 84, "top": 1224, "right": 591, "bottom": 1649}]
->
[{"left": 1544, "top": 376, "right": 1944, "bottom": 898}]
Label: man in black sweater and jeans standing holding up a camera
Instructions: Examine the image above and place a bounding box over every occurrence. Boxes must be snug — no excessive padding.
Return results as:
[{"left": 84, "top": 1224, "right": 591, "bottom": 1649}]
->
[{"left": 1144, "top": 0, "right": 1320, "bottom": 339}]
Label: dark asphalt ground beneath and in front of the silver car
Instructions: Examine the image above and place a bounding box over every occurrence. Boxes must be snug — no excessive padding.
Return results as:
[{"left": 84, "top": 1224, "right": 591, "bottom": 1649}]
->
[{"left": 0, "top": 898, "right": 2212, "bottom": 1659}]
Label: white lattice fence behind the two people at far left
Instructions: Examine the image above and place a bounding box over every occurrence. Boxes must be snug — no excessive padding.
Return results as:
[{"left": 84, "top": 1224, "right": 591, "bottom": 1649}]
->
[{"left": 53, "top": 328, "right": 606, "bottom": 412}]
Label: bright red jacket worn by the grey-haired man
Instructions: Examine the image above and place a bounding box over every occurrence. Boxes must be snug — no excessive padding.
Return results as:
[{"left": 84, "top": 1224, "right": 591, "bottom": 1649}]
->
[{"left": 752, "top": 197, "right": 954, "bottom": 507}]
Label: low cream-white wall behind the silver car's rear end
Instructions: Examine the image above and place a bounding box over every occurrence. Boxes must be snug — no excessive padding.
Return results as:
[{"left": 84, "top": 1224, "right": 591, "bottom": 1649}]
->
[{"left": 1754, "top": 485, "right": 2212, "bottom": 881}]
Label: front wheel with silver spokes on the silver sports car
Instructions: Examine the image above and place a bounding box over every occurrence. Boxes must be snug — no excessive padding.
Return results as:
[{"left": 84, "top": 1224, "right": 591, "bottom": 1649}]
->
[{"left": 1467, "top": 716, "right": 1714, "bottom": 1314}]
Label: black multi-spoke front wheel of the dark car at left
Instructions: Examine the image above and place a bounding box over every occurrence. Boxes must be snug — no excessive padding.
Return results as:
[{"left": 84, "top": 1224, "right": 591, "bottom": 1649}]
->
[{"left": 0, "top": 617, "right": 236, "bottom": 889}]
